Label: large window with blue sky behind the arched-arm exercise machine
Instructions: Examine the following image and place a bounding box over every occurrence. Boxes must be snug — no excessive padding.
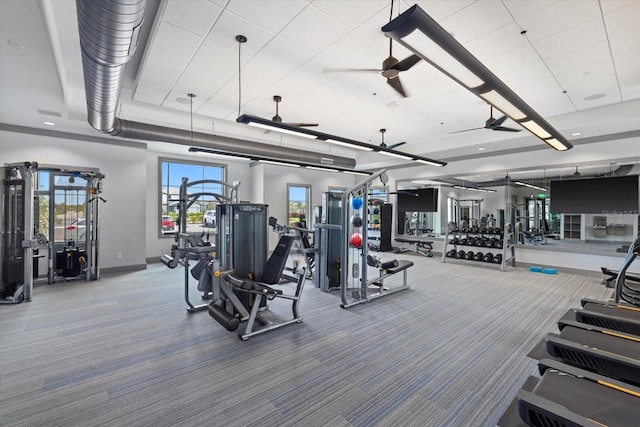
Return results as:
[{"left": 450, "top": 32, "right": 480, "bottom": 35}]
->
[{"left": 158, "top": 159, "right": 228, "bottom": 234}]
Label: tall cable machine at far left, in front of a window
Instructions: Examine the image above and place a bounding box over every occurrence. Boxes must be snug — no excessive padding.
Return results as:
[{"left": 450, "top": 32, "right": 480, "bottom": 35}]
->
[{"left": 0, "top": 162, "right": 106, "bottom": 304}]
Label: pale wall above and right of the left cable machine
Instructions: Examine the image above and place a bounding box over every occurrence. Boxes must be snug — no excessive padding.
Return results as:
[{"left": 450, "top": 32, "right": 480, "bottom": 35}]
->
[{"left": 0, "top": 131, "right": 147, "bottom": 268}]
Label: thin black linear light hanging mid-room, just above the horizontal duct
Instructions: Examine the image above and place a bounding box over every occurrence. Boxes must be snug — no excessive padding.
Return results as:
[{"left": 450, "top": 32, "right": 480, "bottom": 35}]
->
[{"left": 236, "top": 114, "right": 447, "bottom": 167}]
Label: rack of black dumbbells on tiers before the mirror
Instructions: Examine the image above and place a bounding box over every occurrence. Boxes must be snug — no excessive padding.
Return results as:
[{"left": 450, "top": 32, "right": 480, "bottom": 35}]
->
[{"left": 442, "top": 224, "right": 516, "bottom": 271}]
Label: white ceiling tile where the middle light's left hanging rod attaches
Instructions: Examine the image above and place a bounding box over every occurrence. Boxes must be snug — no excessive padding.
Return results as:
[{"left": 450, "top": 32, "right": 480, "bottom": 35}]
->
[{"left": 207, "top": 9, "right": 275, "bottom": 55}]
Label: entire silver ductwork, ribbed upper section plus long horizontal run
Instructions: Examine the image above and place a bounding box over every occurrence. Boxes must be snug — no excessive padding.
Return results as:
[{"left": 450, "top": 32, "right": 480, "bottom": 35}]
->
[{"left": 76, "top": 0, "right": 356, "bottom": 169}]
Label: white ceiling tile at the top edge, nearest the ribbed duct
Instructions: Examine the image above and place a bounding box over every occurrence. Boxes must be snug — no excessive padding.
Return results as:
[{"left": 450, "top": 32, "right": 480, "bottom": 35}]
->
[{"left": 162, "top": 0, "right": 222, "bottom": 36}]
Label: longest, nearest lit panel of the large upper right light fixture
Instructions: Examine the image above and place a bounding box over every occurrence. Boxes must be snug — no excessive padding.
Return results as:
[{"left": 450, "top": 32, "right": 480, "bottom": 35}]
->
[{"left": 403, "top": 30, "right": 484, "bottom": 89}]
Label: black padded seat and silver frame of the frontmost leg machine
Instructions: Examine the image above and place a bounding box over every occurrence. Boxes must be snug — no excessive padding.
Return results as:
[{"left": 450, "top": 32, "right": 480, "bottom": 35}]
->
[{"left": 208, "top": 234, "right": 305, "bottom": 341}]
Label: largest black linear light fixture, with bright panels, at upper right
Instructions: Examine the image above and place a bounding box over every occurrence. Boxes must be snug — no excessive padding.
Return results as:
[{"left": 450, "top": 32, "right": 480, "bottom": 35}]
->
[{"left": 382, "top": 5, "right": 573, "bottom": 151}]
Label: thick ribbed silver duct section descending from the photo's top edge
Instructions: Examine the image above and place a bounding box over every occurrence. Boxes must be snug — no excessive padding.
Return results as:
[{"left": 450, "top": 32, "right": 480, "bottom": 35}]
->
[{"left": 76, "top": 0, "right": 146, "bottom": 132}]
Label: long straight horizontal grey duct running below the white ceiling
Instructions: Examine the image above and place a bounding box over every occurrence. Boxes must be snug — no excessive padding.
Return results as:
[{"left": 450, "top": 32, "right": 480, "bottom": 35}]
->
[{"left": 110, "top": 118, "right": 356, "bottom": 169}]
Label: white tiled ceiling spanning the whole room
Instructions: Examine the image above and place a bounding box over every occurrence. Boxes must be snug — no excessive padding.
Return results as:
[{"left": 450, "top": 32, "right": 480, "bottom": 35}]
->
[{"left": 0, "top": 0, "right": 640, "bottom": 181}]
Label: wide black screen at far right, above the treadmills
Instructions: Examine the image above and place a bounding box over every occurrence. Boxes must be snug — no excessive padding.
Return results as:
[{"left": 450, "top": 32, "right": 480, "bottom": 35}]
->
[{"left": 549, "top": 175, "right": 639, "bottom": 215}]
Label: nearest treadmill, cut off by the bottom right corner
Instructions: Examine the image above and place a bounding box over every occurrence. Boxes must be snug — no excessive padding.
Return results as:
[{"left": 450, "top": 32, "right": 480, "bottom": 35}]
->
[{"left": 517, "top": 360, "right": 640, "bottom": 427}]
